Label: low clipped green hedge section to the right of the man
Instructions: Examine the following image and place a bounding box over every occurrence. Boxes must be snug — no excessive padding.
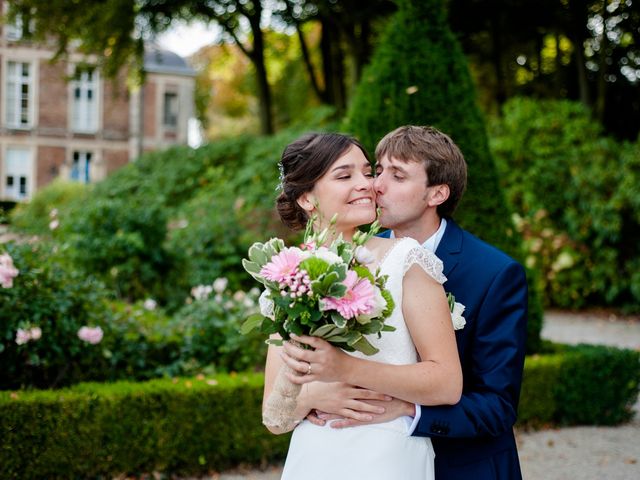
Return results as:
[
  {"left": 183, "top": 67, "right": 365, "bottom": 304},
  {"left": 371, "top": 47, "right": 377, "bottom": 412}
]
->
[{"left": 518, "top": 345, "right": 640, "bottom": 426}]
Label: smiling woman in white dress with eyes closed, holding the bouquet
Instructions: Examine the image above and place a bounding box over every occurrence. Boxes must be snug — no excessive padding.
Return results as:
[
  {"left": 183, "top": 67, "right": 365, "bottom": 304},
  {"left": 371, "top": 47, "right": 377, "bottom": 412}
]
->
[{"left": 263, "top": 133, "right": 462, "bottom": 480}]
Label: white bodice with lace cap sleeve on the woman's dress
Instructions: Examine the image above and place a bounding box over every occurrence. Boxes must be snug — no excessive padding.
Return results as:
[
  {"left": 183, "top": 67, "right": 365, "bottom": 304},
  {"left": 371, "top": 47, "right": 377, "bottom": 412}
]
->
[{"left": 350, "top": 238, "right": 447, "bottom": 365}]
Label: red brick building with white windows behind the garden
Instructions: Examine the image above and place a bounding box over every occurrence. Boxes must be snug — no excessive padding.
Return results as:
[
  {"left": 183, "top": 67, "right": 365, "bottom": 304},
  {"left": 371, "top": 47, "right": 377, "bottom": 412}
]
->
[{"left": 0, "top": 5, "right": 195, "bottom": 201}]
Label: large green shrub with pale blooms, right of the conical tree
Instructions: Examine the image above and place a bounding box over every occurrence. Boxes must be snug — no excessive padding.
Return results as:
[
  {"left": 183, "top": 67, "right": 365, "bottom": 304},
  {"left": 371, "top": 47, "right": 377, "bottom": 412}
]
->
[{"left": 492, "top": 98, "right": 640, "bottom": 312}]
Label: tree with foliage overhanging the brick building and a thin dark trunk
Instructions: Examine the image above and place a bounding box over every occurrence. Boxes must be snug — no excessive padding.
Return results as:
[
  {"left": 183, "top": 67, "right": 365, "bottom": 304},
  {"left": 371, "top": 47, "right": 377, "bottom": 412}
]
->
[{"left": 9, "top": 0, "right": 273, "bottom": 134}]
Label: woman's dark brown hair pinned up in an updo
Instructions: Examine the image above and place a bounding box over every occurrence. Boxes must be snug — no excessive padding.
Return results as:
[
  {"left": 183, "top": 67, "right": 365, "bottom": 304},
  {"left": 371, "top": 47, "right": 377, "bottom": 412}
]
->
[{"left": 276, "top": 133, "right": 370, "bottom": 230}]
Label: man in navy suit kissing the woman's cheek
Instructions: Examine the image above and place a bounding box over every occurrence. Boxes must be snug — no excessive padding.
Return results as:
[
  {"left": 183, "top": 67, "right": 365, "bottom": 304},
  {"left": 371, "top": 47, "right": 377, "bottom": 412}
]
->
[{"left": 309, "top": 126, "right": 527, "bottom": 480}]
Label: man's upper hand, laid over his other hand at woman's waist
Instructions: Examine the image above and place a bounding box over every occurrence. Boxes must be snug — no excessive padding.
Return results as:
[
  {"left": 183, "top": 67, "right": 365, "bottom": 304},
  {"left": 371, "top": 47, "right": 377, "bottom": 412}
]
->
[{"left": 299, "top": 382, "right": 392, "bottom": 425}]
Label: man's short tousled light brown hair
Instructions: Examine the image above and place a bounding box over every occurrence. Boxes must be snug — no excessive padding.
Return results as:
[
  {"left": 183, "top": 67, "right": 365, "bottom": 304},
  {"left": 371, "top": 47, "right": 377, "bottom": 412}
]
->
[{"left": 376, "top": 125, "right": 467, "bottom": 217}]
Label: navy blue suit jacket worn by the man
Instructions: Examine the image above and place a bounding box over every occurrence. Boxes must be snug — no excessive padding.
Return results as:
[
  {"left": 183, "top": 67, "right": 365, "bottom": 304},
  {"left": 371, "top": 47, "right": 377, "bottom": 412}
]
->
[{"left": 384, "top": 219, "right": 527, "bottom": 480}]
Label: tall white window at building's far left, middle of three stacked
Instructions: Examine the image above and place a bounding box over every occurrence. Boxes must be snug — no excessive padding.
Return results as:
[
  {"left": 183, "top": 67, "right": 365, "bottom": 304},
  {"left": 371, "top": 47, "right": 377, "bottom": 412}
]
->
[{"left": 5, "top": 62, "right": 33, "bottom": 128}]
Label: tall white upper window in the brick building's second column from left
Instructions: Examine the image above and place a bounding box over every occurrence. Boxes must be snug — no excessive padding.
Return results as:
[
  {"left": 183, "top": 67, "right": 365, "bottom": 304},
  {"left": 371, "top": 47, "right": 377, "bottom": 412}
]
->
[{"left": 71, "top": 69, "right": 98, "bottom": 133}]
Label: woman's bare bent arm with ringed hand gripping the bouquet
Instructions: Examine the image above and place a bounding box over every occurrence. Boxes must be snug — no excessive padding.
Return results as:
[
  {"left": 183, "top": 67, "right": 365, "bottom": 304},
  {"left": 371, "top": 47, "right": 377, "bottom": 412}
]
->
[{"left": 283, "top": 265, "right": 462, "bottom": 405}]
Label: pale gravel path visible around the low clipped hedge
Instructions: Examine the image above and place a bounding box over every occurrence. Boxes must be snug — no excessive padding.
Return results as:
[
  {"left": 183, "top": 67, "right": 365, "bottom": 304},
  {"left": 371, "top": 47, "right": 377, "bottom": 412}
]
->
[{"left": 199, "top": 311, "right": 640, "bottom": 480}]
